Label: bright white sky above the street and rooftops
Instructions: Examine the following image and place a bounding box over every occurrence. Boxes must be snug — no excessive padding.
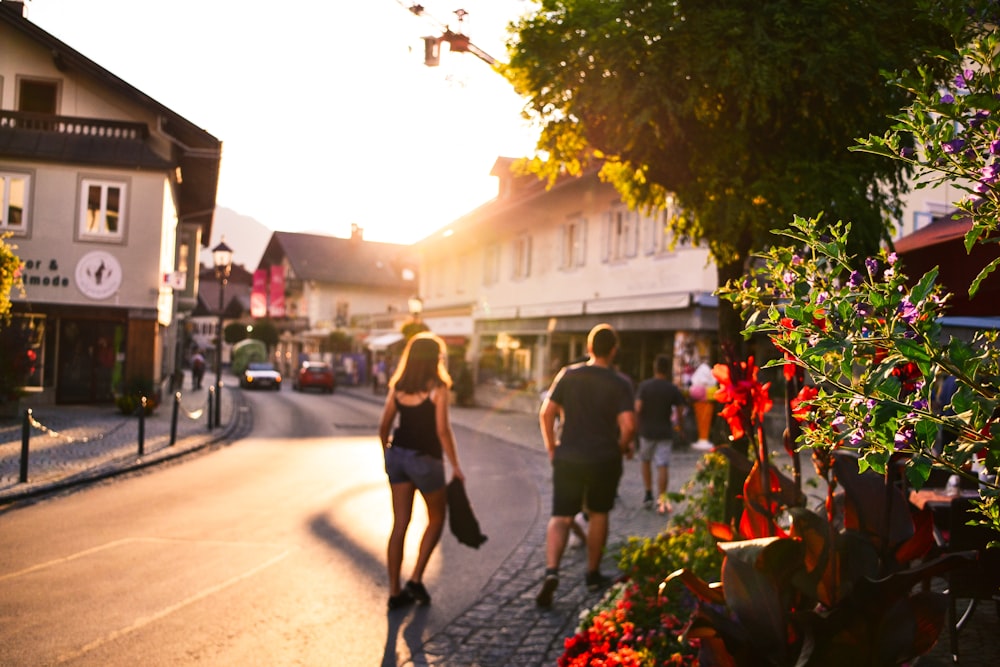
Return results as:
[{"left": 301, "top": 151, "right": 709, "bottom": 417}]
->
[{"left": 27, "top": 0, "right": 537, "bottom": 243}]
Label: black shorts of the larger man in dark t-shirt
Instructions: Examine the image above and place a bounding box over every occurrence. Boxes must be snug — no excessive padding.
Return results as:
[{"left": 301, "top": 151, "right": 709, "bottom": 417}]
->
[{"left": 552, "top": 459, "right": 622, "bottom": 516}]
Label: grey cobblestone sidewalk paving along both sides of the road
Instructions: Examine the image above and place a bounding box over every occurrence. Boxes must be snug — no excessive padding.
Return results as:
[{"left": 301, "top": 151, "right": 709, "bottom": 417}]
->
[{"left": 0, "top": 378, "right": 1000, "bottom": 667}]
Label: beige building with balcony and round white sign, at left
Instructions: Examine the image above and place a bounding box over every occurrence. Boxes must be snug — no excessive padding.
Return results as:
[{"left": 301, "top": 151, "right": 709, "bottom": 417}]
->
[{"left": 0, "top": 0, "right": 221, "bottom": 404}]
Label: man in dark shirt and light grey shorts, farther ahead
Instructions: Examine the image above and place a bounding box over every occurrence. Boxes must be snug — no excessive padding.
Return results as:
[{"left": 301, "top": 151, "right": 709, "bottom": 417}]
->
[{"left": 635, "top": 354, "right": 685, "bottom": 514}]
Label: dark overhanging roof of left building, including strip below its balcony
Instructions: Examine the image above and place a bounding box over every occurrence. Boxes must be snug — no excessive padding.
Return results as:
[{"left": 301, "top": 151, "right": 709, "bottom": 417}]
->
[{"left": 0, "top": 1, "right": 222, "bottom": 237}]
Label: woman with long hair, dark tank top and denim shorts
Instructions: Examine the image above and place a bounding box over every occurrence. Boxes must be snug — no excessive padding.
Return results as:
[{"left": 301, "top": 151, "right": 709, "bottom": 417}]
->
[{"left": 379, "top": 332, "right": 465, "bottom": 609}]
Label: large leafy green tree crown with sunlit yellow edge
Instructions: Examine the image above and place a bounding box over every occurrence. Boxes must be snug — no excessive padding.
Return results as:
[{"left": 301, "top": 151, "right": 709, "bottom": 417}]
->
[{"left": 501, "top": 0, "right": 963, "bottom": 343}]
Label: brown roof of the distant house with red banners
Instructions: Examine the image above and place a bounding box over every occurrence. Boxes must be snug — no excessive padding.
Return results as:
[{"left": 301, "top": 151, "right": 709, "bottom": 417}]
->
[{"left": 260, "top": 232, "right": 417, "bottom": 288}]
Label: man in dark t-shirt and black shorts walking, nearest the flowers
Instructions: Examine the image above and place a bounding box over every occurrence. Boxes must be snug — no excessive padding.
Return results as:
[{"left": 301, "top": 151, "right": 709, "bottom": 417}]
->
[{"left": 535, "top": 324, "right": 635, "bottom": 607}]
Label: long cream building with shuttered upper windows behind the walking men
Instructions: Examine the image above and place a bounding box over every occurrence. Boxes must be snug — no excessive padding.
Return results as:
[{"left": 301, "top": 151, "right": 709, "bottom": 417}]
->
[{"left": 417, "top": 158, "right": 718, "bottom": 391}]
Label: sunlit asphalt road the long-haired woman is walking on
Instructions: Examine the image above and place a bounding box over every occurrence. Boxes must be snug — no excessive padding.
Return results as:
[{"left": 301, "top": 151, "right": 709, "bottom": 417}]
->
[{"left": 0, "top": 391, "right": 542, "bottom": 666}]
